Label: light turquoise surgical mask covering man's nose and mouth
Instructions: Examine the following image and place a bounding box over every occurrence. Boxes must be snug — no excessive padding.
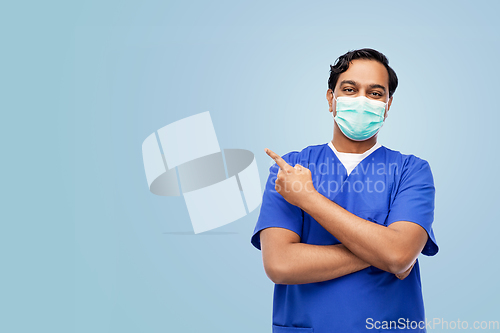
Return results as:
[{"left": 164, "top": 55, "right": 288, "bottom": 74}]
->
[{"left": 333, "top": 96, "right": 387, "bottom": 141}]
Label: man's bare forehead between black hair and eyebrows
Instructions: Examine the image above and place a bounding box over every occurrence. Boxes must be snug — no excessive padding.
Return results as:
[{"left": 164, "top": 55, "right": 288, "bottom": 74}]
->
[{"left": 337, "top": 59, "right": 389, "bottom": 89}]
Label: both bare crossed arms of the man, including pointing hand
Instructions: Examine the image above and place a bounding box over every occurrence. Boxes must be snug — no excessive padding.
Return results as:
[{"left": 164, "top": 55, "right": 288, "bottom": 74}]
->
[{"left": 260, "top": 150, "right": 428, "bottom": 284}]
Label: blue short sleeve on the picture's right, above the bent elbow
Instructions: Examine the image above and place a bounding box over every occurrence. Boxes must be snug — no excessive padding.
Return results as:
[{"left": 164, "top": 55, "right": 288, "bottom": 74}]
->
[{"left": 386, "top": 155, "right": 439, "bottom": 256}]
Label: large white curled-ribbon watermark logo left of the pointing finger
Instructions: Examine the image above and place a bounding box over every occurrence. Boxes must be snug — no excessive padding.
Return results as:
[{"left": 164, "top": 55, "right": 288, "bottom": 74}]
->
[{"left": 142, "top": 111, "right": 262, "bottom": 234}]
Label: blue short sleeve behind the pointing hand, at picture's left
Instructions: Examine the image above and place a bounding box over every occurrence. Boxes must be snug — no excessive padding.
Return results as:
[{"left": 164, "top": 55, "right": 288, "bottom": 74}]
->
[{"left": 251, "top": 152, "right": 303, "bottom": 250}]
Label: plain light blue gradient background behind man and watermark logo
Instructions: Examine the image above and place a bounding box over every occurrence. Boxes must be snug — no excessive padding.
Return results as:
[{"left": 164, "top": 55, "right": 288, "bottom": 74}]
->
[{"left": 0, "top": 1, "right": 500, "bottom": 333}]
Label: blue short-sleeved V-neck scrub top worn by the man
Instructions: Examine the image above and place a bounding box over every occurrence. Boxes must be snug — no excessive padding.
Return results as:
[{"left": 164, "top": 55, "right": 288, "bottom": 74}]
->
[{"left": 251, "top": 144, "right": 438, "bottom": 333}]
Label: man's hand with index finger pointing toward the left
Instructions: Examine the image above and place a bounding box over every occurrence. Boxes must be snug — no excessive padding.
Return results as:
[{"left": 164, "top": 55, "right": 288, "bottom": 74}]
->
[{"left": 264, "top": 148, "right": 318, "bottom": 208}]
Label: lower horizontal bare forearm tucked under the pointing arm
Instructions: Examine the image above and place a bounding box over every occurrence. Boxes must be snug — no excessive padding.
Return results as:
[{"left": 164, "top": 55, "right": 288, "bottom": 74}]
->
[{"left": 260, "top": 227, "right": 370, "bottom": 284}]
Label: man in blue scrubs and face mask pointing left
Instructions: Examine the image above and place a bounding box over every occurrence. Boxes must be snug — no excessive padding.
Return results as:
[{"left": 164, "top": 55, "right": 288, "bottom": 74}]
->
[{"left": 251, "top": 49, "right": 438, "bottom": 333}]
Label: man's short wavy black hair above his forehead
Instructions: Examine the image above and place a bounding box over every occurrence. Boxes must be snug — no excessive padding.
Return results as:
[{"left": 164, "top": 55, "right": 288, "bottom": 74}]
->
[{"left": 328, "top": 48, "right": 398, "bottom": 98}]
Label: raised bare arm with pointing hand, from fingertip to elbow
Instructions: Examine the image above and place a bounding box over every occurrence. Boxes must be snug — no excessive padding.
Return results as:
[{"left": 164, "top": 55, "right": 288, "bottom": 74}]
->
[{"left": 266, "top": 149, "right": 428, "bottom": 275}]
